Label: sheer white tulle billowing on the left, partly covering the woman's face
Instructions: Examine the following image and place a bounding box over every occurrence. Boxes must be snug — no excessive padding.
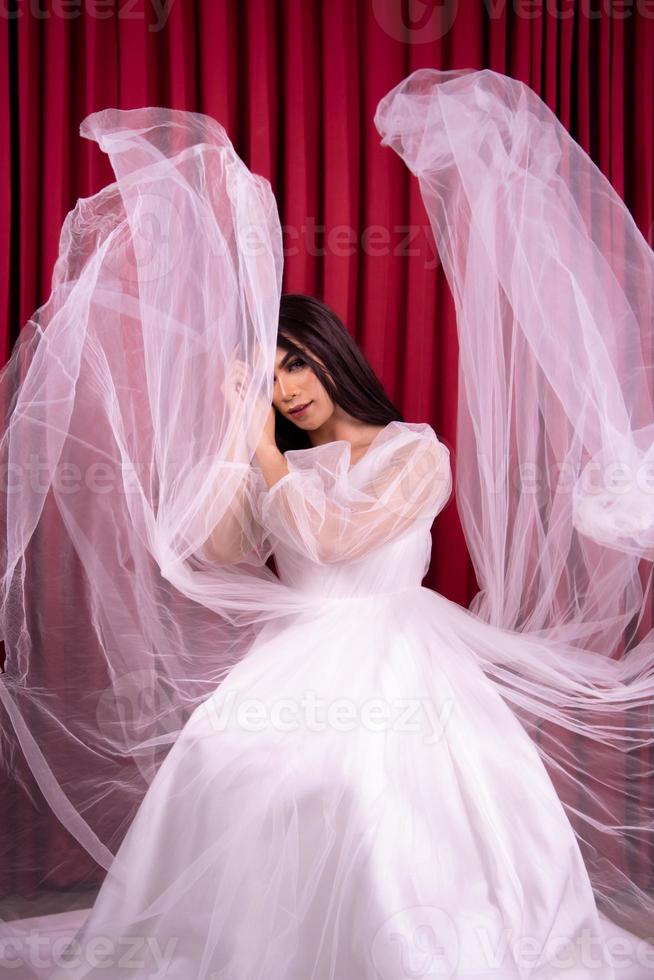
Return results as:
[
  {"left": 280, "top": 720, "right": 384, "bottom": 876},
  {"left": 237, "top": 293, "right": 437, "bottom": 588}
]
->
[{"left": 0, "top": 108, "right": 304, "bottom": 887}]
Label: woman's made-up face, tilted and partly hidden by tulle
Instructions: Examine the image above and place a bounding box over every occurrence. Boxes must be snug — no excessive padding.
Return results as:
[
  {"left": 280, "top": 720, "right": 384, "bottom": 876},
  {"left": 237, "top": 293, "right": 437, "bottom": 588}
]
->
[{"left": 273, "top": 342, "right": 334, "bottom": 429}]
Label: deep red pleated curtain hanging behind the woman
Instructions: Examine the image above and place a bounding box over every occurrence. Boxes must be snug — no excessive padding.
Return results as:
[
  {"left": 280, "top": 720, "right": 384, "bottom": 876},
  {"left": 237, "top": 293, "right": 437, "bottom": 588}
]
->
[{"left": 0, "top": 0, "right": 654, "bottom": 904}]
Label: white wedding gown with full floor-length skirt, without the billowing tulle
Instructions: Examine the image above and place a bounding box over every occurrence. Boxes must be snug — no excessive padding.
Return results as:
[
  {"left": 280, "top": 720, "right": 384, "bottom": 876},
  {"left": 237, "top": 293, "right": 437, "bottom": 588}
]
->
[{"left": 10, "top": 422, "right": 654, "bottom": 980}]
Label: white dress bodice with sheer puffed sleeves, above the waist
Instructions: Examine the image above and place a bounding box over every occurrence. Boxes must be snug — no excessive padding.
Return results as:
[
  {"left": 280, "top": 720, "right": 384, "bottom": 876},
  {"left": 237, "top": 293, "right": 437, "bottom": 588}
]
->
[{"left": 258, "top": 421, "right": 452, "bottom": 597}]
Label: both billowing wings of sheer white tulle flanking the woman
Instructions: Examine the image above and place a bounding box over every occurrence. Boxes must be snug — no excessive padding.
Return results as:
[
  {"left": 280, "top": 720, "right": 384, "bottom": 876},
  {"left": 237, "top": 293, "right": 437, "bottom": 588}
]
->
[{"left": 0, "top": 70, "right": 654, "bottom": 932}]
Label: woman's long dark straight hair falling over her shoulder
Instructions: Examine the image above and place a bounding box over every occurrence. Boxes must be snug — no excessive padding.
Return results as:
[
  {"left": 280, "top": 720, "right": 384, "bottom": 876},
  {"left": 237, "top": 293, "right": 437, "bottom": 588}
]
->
[{"left": 275, "top": 293, "right": 404, "bottom": 452}]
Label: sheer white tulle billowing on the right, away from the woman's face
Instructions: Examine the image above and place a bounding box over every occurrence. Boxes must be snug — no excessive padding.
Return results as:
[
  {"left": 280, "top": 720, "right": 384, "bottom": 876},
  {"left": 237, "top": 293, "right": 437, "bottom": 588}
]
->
[{"left": 375, "top": 69, "right": 654, "bottom": 920}]
